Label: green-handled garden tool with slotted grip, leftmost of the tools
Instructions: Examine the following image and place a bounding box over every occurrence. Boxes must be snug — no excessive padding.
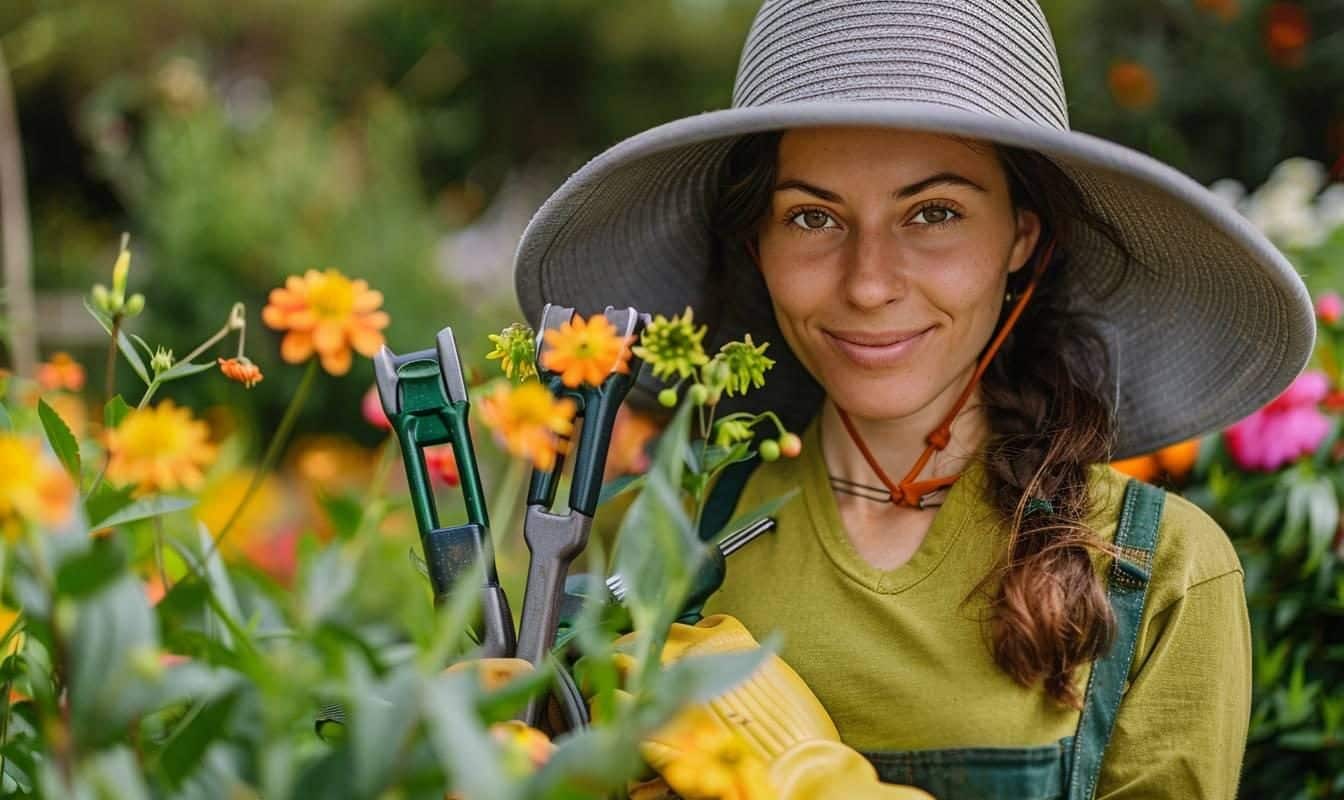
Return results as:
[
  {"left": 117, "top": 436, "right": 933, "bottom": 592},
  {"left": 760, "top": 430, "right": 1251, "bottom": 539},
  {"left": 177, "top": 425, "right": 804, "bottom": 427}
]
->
[{"left": 374, "top": 328, "right": 515, "bottom": 657}]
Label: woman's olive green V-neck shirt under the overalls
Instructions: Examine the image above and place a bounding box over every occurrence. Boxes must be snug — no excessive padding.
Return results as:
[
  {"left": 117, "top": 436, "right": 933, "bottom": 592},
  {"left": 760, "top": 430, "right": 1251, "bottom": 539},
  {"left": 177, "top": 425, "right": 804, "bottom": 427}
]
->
[{"left": 666, "top": 422, "right": 1251, "bottom": 799}]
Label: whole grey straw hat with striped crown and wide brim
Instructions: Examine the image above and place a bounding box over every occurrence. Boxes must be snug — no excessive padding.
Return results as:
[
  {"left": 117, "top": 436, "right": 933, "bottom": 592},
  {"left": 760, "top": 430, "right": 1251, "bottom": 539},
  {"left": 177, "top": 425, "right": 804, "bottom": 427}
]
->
[{"left": 515, "top": 0, "right": 1316, "bottom": 457}]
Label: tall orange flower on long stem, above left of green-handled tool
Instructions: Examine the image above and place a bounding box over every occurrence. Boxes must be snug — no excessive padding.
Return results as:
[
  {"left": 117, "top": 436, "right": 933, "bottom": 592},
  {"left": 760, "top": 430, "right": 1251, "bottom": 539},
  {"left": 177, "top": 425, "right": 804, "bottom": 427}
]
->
[{"left": 261, "top": 269, "right": 388, "bottom": 375}]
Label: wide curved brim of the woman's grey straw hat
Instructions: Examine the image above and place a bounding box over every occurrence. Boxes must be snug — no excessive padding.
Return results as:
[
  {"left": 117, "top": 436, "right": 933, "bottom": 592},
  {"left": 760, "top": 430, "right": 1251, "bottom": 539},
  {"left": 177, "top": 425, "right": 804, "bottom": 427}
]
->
[{"left": 515, "top": 101, "right": 1316, "bottom": 458}]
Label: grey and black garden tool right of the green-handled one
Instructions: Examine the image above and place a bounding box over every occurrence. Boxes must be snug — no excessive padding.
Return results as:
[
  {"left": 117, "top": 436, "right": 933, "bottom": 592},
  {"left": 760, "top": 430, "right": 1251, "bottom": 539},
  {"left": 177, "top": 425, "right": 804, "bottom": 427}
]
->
[{"left": 517, "top": 304, "right": 649, "bottom": 709}]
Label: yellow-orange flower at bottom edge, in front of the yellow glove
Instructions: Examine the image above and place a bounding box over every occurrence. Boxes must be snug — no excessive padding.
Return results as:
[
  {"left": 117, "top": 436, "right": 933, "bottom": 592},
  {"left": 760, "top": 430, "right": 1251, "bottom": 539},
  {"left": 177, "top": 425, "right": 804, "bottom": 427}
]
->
[{"left": 656, "top": 706, "right": 777, "bottom": 800}]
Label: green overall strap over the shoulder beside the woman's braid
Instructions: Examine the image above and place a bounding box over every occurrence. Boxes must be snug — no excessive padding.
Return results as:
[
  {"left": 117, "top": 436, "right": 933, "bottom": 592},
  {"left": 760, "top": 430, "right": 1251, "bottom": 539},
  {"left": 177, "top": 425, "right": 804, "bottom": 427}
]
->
[{"left": 1067, "top": 480, "right": 1167, "bottom": 800}]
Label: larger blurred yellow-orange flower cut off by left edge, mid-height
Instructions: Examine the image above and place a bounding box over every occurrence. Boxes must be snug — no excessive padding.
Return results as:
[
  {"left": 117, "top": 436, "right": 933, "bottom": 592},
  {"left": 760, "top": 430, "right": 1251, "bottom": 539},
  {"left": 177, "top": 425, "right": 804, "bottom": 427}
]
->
[{"left": 0, "top": 433, "right": 75, "bottom": 541}]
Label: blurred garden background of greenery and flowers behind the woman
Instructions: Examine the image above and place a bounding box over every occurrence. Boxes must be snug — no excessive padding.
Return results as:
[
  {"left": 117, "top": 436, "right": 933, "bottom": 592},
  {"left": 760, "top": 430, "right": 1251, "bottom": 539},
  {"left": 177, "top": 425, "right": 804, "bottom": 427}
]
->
[{"left": 0, "top": 0, "right": 1344, "bottom": 797}]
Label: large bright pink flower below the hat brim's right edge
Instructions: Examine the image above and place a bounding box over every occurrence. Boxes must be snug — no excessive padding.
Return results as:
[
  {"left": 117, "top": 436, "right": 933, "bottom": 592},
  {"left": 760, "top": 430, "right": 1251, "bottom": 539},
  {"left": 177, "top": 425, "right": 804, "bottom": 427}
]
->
[{"left": 1223, "top": 371, "right": 1331, "bottom": 472}]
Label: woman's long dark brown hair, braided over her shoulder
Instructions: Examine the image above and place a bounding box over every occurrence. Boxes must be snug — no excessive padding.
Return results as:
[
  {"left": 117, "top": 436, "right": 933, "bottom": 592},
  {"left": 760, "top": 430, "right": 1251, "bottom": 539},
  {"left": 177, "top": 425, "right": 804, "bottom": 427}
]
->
[{"left": 711, "top": 132, "right": 1125, "bottom": 707}]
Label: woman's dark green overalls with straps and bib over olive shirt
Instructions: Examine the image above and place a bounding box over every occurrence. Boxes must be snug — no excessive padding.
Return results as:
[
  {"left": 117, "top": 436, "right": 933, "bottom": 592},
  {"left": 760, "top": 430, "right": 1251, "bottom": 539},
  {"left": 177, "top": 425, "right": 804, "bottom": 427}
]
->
[{"left": 700, "top": 461, "right": 1165, "bottom": 800}]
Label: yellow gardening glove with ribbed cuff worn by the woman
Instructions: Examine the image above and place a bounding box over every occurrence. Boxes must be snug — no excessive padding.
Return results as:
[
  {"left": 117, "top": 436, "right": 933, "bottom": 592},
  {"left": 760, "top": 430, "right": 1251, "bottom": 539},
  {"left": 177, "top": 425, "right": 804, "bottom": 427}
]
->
[{"left": 617, "top": 614, "right": 933, "bottom": 800}]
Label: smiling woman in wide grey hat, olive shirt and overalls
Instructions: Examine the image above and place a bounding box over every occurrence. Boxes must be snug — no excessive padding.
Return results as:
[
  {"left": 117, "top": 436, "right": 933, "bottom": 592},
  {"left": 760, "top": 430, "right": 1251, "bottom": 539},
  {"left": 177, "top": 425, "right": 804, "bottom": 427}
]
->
[{"left": 505, "top": 0, "right": 1313, "bottom": 799}]
